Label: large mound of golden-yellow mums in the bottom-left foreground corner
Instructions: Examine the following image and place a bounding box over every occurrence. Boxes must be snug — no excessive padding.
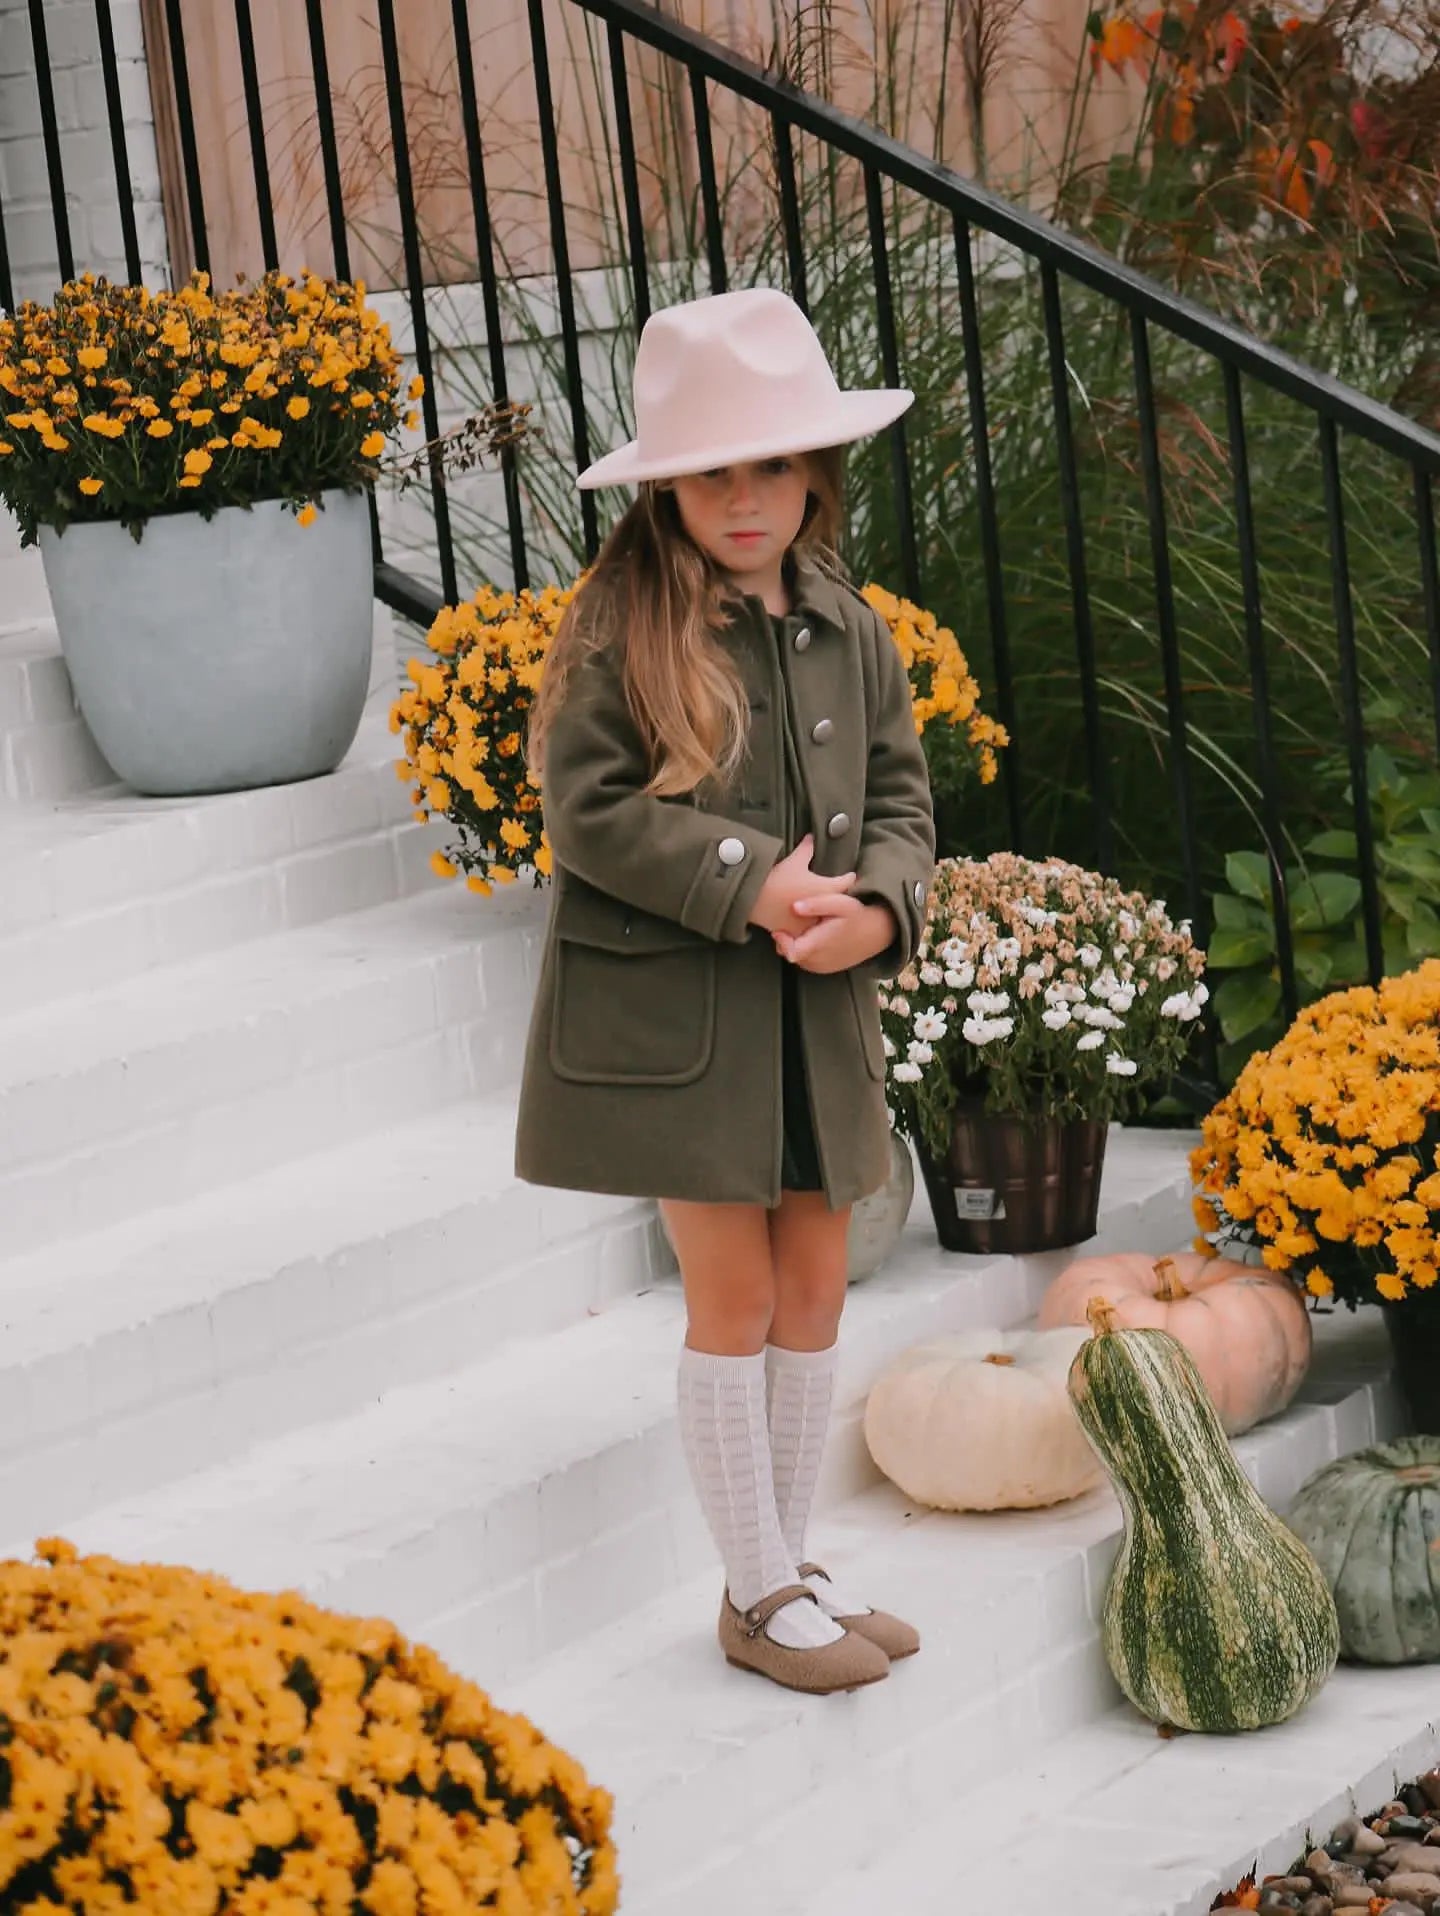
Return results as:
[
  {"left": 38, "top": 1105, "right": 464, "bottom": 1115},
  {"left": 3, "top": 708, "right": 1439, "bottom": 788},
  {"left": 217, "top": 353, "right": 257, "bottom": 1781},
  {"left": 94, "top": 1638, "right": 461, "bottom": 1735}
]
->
[{"left": 0, "top": 1540, "right": 619, "bottom": 1916}]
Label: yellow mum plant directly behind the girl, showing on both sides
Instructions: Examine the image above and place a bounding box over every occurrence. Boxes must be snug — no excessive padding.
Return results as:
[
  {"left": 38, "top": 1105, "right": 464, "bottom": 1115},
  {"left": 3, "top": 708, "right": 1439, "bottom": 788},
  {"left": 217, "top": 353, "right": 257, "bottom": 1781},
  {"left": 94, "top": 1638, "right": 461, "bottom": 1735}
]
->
[{"left": 391, "top": 581, "right": 1009, "bottom": 895}]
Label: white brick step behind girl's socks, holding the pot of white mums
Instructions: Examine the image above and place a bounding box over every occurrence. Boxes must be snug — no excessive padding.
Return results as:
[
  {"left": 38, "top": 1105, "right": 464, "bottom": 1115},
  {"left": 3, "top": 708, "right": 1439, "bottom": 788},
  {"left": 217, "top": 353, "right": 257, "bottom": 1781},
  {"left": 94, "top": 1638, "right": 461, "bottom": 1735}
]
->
[{"left": 42, "top": 1134, "right": 1185, "bottom": 1677}]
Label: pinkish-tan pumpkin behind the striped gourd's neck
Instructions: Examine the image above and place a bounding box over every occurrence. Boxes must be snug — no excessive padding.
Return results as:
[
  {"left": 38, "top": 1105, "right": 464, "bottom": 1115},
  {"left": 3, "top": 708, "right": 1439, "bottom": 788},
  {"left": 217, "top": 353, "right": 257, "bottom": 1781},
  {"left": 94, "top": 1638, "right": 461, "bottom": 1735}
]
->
[{"left": 1036, "top": 1251, "right": 1312, "bottom": 1437}]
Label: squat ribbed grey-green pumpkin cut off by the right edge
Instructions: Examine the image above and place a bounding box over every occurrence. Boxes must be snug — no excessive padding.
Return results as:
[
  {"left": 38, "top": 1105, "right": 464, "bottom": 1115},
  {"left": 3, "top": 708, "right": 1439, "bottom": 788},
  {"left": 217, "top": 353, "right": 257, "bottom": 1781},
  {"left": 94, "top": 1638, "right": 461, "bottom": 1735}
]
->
[{"left": 1291, "top": 1437, "right": 1440, "bottom": 1663}]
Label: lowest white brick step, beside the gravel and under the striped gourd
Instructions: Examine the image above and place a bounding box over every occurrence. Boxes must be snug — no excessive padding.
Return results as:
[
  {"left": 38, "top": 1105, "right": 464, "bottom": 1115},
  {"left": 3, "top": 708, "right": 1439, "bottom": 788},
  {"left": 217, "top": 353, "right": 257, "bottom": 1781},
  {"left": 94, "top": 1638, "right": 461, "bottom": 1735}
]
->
[{"left": 811, "top": 1663, "right": 1440, "bottom": 1916}]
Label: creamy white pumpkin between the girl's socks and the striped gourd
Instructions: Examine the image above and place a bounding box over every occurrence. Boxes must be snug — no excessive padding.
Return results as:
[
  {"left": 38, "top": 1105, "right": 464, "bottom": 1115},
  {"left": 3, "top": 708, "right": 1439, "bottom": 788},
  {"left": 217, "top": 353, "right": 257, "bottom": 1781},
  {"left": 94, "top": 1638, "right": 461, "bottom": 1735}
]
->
[{"left": 866, "top": 1328, "right": 1105, "bottom": 1510}]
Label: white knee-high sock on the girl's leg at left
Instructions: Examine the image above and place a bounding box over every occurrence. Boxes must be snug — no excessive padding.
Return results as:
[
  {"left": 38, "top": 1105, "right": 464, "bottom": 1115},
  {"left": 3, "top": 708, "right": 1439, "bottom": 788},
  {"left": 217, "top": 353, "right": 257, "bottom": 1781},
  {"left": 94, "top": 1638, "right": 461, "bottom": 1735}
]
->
[{"left": 678, "top": 1345, "right": 843, "bottom": 1650}]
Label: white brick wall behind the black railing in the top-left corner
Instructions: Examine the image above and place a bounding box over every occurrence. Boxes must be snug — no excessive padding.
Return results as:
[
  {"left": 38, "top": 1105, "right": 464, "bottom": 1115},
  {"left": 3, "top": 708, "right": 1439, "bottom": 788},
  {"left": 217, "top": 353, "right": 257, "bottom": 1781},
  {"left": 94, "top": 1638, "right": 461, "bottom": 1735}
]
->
[{"left": 0, "top": 0, "right": 170, "bottom": 301}]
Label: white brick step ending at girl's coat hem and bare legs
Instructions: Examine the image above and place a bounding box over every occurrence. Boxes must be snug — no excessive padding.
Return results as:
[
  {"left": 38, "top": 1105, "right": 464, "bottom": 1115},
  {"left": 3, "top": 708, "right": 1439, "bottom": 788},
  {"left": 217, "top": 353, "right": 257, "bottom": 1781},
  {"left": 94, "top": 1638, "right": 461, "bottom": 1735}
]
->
[{"left": 0, "top": 1094, "right": 668, "bottom": 1537}]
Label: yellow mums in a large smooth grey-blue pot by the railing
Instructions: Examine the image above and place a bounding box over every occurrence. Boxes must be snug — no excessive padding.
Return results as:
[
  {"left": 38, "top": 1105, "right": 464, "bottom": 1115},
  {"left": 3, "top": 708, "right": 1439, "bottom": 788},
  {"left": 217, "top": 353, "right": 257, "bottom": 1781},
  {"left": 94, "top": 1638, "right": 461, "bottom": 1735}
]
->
[{"left": 0, "top": 272, "right": 417, "bottom": 793}]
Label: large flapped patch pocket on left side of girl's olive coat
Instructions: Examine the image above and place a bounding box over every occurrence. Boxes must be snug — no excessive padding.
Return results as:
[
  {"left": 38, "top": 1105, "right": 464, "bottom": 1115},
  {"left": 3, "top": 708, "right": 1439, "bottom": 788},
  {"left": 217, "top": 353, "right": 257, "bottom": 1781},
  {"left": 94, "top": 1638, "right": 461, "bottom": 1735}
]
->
[{"left": 550, "top": 893, "right": 716, "bottom": 1084}]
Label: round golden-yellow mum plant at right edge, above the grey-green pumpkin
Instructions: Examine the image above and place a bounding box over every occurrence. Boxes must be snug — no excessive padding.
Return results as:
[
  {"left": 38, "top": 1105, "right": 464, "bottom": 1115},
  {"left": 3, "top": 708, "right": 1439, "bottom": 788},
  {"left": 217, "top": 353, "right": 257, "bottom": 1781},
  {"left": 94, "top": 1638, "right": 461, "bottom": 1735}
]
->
[{"left": 1191, "top": 958, "right": 1440, "bottom": 1311}]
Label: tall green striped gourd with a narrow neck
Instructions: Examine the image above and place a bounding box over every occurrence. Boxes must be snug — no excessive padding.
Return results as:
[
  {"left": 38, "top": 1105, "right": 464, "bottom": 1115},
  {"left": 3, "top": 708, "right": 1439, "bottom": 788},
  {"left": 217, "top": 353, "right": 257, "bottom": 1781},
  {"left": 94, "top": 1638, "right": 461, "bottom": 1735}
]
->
[{"left": 1069, "top": 1305, "right": 1340, "bottom": 1732}]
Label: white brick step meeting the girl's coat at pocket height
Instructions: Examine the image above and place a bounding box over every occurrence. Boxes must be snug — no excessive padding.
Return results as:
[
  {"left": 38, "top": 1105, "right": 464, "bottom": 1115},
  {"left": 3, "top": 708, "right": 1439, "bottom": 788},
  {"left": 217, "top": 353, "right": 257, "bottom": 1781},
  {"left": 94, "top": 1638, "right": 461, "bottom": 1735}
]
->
[{"left": 0, "top": 889, "right": 540, "bottom": 1251}]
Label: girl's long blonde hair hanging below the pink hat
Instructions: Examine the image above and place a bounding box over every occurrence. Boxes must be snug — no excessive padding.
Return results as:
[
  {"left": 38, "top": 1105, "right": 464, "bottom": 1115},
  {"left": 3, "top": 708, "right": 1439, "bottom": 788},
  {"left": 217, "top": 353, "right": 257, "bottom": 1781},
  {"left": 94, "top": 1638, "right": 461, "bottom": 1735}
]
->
[{"left": 527, "top": 446, "right": 844, "bottom": 797}]
